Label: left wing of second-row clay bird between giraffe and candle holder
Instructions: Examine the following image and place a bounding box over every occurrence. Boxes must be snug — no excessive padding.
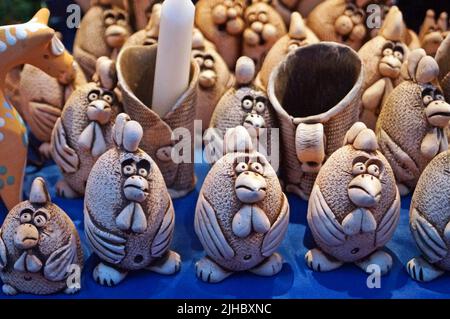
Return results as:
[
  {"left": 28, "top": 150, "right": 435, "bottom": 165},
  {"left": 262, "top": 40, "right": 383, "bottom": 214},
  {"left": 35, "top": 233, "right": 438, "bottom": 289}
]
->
[{"left": 51, "top": 118, "right": 80, "bottom": 173}]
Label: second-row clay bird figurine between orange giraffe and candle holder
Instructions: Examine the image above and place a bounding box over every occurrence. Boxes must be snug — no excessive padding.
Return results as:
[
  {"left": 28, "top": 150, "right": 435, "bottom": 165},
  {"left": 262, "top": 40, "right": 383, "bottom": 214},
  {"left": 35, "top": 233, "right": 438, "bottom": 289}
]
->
[{"left": 51, "top": 57, "right": 121, "bottom": 198}]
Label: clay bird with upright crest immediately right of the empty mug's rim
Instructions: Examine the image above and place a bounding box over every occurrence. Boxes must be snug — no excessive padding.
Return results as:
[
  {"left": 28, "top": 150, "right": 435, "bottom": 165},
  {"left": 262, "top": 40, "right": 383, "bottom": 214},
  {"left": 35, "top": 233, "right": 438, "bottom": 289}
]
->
[{"left": 358, "top": 6, "right": 409, "bottom": 130}]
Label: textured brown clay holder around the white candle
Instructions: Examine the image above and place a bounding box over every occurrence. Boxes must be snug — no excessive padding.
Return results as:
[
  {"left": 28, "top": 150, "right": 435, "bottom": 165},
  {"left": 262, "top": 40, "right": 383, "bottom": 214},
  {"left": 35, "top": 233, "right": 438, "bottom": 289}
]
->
[{"left": 116, "top": 45, "right": 199, "bottom": 198}]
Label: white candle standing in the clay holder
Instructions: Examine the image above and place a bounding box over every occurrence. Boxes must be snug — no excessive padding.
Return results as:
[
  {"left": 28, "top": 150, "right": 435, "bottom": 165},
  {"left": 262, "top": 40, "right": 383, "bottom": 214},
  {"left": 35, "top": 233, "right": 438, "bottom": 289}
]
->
[{"left": 152, "top": 0, "right": 195, "bottom": 117}]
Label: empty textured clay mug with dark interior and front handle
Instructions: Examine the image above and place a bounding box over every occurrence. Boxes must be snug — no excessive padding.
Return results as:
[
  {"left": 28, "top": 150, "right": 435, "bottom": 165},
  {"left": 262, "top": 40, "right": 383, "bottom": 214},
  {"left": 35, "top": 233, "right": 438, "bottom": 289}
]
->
[{"left": 268, "top": 42, "right": 363, "bottom": 199}]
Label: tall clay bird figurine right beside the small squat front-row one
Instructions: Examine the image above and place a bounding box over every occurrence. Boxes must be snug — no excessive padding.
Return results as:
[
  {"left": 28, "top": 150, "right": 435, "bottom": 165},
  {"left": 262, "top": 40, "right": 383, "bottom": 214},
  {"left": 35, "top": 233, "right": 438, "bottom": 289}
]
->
[{"left": 84, "top": 113, "right": 181, "bottom": 286}]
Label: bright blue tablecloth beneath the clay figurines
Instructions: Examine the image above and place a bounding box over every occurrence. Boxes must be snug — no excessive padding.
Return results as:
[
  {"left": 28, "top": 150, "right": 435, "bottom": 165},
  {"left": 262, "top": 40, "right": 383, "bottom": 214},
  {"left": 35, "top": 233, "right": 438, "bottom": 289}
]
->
[{"left": 0, "top": 150, "right": 450, "bottom": 298}]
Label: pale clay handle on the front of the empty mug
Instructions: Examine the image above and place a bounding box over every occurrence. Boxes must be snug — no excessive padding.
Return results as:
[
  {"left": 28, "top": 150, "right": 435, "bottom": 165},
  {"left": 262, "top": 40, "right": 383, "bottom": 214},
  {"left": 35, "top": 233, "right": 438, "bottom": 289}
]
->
[{"left": 295, "top": 123, "right": 325, "bottom": 173}]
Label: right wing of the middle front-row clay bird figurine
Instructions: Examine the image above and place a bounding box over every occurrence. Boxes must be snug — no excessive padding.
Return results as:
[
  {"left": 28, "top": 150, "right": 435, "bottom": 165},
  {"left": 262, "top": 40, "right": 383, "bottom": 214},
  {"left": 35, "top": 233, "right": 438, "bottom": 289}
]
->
[{"left": 261, "top": 194, "right": 289, "bottom": 257}]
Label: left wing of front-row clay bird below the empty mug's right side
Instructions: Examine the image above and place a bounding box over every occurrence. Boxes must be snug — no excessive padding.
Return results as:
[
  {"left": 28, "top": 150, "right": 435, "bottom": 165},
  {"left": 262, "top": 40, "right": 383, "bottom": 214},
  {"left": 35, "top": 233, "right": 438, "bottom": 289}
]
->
[{"left": 307, "top": 185, "right": 345, "bottom": 246}]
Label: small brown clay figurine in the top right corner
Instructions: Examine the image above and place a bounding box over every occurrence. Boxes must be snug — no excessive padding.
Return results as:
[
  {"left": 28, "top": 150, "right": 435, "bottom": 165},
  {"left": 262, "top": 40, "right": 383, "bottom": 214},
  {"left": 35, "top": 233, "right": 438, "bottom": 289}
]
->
[{"left": 419, "top": 9, "right": 449, "bottom": 57}]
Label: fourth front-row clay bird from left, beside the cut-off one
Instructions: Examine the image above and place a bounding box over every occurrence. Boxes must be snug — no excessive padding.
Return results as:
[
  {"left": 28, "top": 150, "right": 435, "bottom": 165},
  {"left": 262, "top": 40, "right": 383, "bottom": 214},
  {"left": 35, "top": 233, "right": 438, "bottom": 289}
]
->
[{"left": 305, "top": 122, "right": 400, "bottom": 274}]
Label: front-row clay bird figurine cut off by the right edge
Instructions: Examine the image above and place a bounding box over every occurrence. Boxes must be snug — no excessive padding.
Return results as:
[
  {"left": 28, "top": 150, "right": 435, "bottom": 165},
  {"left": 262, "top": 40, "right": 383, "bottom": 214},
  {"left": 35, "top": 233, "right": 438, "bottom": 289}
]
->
[{"left": 406, "top": 151, "right": 450, "bottom": 281}]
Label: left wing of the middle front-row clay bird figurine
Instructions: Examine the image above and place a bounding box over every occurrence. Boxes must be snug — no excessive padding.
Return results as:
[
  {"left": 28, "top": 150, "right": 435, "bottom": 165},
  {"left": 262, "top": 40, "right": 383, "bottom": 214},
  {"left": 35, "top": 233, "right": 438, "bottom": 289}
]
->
[{"left": 194, "top": 194, "right": 235, "bottom": 259}]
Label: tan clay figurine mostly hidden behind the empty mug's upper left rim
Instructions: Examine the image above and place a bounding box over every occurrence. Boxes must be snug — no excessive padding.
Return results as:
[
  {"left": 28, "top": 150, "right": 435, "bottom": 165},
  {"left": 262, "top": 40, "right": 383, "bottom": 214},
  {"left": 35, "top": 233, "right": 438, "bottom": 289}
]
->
[{"left": 256, "top": 12, "right": 319, "bottom": 89}]
